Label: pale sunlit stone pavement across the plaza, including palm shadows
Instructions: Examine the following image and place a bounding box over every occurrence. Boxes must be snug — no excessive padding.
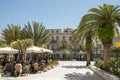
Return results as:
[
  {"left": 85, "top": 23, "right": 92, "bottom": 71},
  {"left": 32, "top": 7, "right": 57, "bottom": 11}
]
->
[{"left": 0, "top": 61, "right": 103, "bottom": 80}]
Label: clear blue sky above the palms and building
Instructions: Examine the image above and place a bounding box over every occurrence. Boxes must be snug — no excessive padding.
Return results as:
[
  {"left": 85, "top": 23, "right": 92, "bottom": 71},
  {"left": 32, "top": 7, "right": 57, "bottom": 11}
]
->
[{"left": 0, "top": 0, "right": 120, "bottom": 32}]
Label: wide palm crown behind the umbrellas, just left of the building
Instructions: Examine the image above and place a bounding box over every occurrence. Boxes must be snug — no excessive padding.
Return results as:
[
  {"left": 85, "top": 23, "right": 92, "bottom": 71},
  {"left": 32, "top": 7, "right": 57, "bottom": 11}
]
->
[{"left": 21, "top": 22, "right": 49, "bottom": 46}]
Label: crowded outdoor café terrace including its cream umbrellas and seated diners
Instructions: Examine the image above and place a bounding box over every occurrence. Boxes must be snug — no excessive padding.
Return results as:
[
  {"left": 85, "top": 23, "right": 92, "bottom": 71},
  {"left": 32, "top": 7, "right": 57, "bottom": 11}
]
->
[{"left": 0, "top": 46, "right": 58, "bottom": 77}]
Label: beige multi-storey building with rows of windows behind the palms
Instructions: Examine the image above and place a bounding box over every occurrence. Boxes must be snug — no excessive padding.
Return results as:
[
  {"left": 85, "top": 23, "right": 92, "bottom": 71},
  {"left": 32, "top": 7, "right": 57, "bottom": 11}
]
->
[{"left": 47, "top": 28, "right": 73, "bottom": 51}]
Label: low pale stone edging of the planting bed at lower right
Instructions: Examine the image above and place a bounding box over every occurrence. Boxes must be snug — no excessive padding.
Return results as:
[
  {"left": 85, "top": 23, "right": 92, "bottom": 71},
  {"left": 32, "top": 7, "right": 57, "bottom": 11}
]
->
[{"left": 89, "top": 65, "right": 120, "bottom": 80}]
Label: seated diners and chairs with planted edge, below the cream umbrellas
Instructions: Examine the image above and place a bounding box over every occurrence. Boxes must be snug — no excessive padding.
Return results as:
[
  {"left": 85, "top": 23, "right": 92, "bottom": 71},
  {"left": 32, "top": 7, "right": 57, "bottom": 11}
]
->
[{"left": 0, "top": 60, "right": 58, "bottom": 77}]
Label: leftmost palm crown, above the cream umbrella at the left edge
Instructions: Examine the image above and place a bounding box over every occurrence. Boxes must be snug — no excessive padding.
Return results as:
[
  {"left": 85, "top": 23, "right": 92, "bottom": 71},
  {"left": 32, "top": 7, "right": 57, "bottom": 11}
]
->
[{"left": 2, "top": 24, "right": 21, "bottom": 45}]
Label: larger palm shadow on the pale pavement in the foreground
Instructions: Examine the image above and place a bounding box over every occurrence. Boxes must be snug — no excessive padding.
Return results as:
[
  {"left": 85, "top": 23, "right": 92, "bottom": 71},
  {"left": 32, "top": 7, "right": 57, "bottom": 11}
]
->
[{"left": 65, "top": 72, "right": 103, "bottom": 80}]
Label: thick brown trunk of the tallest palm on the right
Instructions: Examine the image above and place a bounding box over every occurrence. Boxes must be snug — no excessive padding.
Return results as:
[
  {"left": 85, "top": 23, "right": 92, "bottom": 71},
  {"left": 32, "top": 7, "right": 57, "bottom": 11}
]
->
[{"left": 103, "top": 41, "right": 112, "bottom": 70}]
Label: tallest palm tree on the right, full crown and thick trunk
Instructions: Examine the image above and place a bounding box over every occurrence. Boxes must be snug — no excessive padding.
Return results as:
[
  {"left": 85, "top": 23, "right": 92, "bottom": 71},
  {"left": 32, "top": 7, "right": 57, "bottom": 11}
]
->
[{"left": 79, "top": 4, "right": 120, "bottom": 69}]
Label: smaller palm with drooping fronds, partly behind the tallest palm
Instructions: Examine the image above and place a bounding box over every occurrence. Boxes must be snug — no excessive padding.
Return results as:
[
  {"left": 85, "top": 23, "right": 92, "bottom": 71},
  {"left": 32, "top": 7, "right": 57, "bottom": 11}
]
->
[{"left": 71, "top": 26, "right": 93, "bottom": 66}]
